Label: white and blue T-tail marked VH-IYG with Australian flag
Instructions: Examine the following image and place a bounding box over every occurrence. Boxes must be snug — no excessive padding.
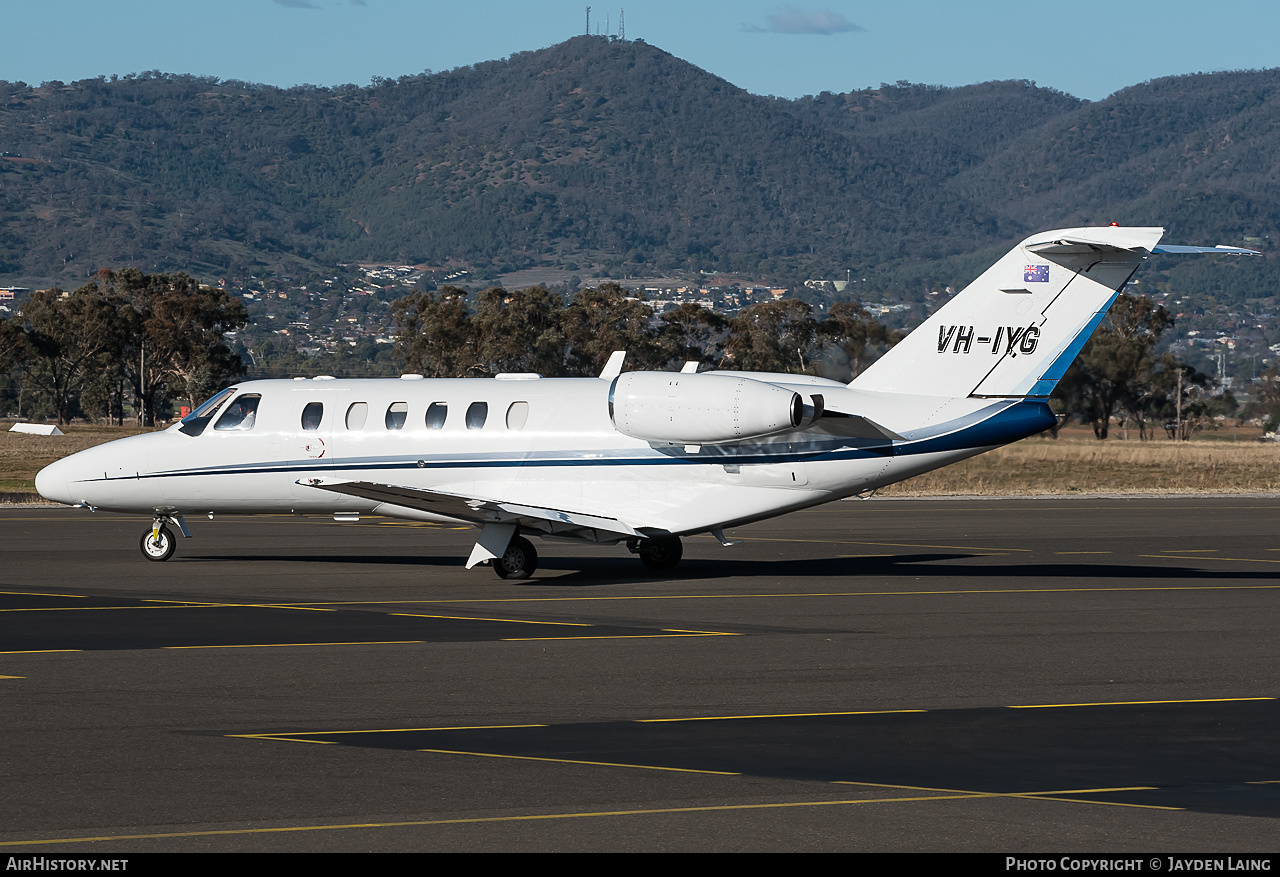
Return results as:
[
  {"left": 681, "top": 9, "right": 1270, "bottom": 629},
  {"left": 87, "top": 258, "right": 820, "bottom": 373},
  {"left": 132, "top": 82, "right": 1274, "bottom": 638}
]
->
[{"left": 850, "top": 225, "right": 1257, "bottom": 399}]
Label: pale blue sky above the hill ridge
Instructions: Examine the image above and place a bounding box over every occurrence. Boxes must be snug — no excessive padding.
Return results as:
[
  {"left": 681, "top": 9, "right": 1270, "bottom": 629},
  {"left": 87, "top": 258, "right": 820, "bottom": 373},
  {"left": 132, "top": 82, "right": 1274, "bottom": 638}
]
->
[{"left": 0, "top": 0, "right": 1280, "bottom": 100}]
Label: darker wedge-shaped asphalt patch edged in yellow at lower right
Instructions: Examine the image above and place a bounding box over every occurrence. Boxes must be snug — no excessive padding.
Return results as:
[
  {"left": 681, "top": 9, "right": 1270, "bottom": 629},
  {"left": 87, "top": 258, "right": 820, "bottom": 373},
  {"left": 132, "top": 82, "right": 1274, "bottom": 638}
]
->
[{"left": 238, "top": 698, "right": 1280, "bottom": 817}]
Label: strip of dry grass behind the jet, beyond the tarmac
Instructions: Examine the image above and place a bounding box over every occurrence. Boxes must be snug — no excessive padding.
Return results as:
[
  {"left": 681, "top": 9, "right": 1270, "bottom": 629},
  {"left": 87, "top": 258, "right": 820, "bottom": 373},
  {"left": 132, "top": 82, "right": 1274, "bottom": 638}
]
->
[{"left": 0, "top": 424, "right": 1280, "bottom": 502}]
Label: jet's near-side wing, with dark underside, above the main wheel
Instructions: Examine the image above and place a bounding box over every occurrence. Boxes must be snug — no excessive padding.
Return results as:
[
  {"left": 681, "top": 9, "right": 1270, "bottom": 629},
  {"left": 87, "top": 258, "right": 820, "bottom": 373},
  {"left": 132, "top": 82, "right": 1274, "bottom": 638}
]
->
[{"left": 298, "top": 478, "right": 641, "bottom": 542}]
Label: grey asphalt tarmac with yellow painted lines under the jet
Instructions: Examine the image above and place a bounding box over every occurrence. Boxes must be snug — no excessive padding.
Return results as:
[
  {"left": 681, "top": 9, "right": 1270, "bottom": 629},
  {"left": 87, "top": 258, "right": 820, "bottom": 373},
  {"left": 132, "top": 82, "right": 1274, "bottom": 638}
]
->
[{"left": 0, "top": 497, "right": 1280, "bottom": 855}]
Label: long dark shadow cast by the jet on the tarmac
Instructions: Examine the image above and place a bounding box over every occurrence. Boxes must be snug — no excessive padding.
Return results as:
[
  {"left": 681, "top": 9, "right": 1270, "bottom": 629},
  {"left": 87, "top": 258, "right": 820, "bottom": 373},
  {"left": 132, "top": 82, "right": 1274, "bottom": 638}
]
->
[{"left": 180, "top": 552, "right": 1280, "bottom": 588}]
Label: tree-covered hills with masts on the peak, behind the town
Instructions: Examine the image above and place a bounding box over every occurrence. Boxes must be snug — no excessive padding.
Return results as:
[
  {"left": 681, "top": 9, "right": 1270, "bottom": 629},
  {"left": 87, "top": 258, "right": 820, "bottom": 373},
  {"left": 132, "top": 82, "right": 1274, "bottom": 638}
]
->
[{"left": 0, "top": 36, "right": 1280, "bottom": 296}]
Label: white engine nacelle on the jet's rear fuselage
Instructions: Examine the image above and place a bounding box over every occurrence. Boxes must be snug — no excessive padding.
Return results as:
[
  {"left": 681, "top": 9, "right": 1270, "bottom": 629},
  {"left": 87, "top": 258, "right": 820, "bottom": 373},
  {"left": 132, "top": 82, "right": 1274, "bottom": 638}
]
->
[{"left": 609, "top": 371, "right": 804, "bottom": 444}]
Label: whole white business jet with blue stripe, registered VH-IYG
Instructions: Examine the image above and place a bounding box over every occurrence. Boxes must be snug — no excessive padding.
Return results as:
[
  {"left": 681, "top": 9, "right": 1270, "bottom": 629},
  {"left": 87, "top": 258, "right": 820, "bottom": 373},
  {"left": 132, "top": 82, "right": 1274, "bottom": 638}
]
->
[{"left": 36, "top": 225, "right": 1257, "bottom": 579}]
